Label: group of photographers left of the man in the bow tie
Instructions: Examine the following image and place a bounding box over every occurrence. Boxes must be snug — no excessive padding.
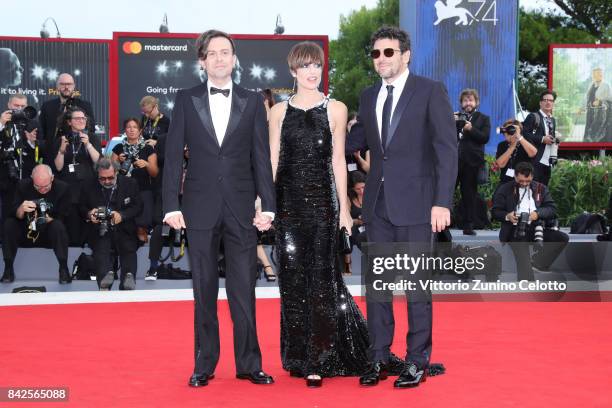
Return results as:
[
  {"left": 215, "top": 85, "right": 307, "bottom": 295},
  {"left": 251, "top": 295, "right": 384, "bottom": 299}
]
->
[{"left": 0, "top": 74, "right": 170, "bottom": 290}]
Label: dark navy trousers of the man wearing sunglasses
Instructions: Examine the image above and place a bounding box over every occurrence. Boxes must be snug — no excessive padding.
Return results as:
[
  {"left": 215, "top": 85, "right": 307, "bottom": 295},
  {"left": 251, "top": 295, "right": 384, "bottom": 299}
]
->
[{"left": 366, "top": 186, "right": 432, "bottom": 368}]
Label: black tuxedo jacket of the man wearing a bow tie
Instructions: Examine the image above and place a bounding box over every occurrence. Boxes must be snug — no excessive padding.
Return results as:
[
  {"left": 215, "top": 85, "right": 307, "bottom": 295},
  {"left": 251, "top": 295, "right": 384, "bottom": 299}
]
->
[{"left": 162, "top": 83, "right": 276, "bottom": 229}]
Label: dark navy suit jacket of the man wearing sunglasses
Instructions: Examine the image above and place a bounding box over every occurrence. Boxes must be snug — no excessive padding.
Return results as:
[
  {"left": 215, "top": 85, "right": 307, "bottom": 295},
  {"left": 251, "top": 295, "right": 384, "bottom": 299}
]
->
[{"left": 346, "top": 74, "right": 458, "bottom": 226}]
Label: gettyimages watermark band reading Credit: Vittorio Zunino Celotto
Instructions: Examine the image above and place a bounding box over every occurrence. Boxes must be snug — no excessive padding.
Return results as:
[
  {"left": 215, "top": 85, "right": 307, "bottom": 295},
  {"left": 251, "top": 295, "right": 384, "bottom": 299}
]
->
[{"left": 362, "top": 243, "right": 592, "bottom": 301}]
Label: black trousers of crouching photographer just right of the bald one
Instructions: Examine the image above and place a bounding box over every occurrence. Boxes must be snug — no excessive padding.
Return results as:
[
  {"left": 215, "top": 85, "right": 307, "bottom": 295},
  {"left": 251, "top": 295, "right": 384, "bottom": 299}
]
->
[{"left": 89, "top": 227, "right": 138, "bottom": 287}]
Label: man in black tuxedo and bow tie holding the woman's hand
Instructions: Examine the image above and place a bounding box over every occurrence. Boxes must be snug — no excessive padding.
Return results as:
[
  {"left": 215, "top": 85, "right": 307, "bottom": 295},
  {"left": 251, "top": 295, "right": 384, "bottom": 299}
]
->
[{"left": 163, "top": 30, "right": 275, "bottom": 387}]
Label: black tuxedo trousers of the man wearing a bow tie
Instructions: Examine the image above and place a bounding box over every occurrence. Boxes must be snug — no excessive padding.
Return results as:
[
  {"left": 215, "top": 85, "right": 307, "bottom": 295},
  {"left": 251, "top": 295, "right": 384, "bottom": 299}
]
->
[{"left": 187, "top": 204, "right": 261, "bottom": 374}]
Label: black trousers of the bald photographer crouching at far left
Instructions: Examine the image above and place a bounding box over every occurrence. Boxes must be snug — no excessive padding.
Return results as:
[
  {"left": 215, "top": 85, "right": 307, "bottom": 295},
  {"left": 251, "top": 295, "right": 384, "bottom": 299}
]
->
[{"left": 2, "top": 217, "right": 68, "bottom": 266}]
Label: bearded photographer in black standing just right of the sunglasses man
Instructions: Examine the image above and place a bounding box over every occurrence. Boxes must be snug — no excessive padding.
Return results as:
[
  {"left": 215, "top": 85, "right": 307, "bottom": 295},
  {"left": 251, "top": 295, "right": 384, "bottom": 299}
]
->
[{"left": 455, "top": 89, "right": 491, "bottom": 235}]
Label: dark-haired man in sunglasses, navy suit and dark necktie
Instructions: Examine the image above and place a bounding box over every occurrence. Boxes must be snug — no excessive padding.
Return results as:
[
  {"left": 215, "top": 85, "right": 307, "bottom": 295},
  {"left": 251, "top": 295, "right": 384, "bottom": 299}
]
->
[{"left": 346, "top": 27, "right": 457, "bottom": 388}]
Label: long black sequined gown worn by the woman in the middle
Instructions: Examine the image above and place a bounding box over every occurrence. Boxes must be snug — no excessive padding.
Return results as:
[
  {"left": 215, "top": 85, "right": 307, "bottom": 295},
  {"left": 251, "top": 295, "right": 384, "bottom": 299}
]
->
[{"left": 275, "top": 99, "right": 368, "bottom": 377}]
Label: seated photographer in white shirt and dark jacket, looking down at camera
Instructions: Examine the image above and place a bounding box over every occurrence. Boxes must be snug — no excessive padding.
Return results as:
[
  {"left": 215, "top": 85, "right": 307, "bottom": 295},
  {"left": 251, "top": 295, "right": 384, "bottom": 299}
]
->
[{"left": 491, "top": 162, "right": 569, "bottom": 280}]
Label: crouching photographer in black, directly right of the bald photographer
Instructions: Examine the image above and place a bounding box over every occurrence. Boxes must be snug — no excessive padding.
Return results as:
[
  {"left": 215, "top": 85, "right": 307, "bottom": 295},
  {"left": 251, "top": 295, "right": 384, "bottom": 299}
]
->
[{"left": 81, "top": 157, "right": 142, "bottom": 290}]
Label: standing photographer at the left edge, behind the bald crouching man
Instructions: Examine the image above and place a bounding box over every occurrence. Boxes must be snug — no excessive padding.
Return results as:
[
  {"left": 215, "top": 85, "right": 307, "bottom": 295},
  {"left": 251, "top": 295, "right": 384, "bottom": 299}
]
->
[{"left": 0, "top": 94, "right": 45, "bottom": 231}]
